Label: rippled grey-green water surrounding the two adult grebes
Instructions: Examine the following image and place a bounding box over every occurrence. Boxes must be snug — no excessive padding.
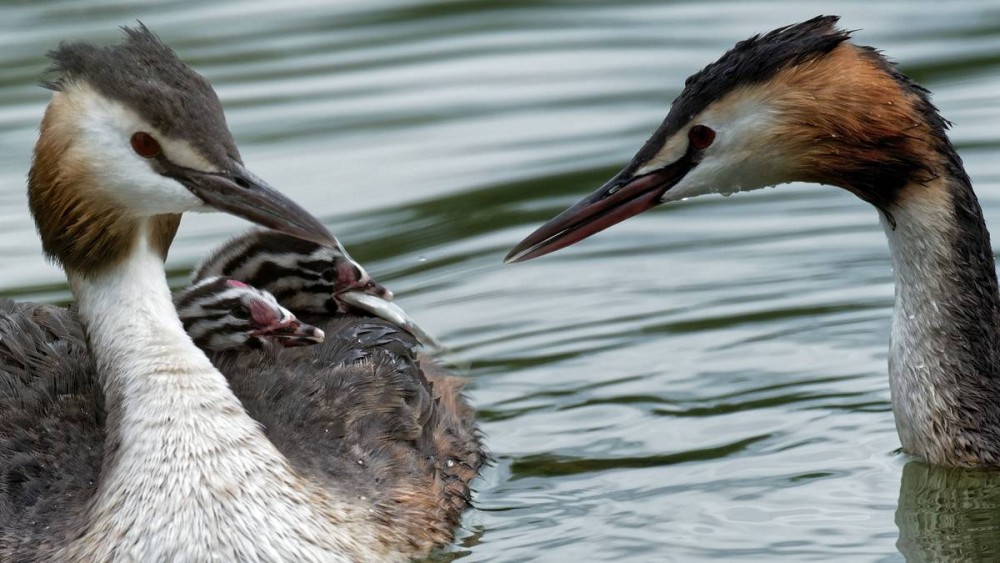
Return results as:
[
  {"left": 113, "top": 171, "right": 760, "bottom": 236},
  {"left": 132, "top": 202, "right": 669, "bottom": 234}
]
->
[{"left": 0, "top": 0, "right": 1000, "bottom": 561}]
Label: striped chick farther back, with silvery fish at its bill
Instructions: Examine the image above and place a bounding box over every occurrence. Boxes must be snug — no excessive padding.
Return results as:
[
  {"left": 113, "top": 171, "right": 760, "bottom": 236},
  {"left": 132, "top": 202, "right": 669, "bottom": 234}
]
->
[{"left": 191, "top": 229, "right": 392, "bottom": 316}]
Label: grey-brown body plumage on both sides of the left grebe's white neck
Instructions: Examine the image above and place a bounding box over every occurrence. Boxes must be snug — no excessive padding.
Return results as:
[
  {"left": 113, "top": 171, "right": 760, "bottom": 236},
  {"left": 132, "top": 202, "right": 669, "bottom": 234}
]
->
[{"left": 0, "top": 299, "right": 486, "bottom": 561}]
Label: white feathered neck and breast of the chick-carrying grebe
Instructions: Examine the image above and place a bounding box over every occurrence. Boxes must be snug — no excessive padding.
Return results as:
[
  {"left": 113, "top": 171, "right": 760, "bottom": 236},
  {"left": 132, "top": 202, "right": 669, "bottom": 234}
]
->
[{"left": 58, "top": 231, "right": 382, "bottom": 561}]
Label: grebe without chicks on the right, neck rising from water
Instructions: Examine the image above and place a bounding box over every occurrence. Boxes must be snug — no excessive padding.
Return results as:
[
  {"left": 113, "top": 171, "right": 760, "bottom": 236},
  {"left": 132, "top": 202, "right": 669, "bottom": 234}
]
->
[{"left": 507, "top": 16, "right": 1000, "bottom": 466}]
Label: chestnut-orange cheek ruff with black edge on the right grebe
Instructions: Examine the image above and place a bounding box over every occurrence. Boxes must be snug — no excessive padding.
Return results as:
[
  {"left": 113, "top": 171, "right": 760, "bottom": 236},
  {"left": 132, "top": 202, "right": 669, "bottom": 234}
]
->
[{"left": 765, "top": 43, "right": 944, "bottom": 212}]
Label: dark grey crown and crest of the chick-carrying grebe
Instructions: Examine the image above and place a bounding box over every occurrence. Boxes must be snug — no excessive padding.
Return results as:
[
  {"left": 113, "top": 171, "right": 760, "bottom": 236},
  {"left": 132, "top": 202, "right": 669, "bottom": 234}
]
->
[{"left": 43, "top": 22, "right": 239, "bottom": 162}]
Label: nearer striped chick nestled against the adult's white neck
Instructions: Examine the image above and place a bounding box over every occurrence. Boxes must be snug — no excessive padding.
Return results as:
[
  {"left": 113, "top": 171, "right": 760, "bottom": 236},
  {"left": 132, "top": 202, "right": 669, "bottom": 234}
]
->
[{"left": 174, "top": 276, "right": 324, "bottom": 351}]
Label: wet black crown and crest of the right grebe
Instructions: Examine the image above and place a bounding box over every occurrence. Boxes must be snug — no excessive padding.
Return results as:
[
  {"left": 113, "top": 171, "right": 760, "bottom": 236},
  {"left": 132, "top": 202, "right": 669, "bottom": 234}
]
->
[{"left": 630, "top": 16, "right": 850, "bottom": 174}]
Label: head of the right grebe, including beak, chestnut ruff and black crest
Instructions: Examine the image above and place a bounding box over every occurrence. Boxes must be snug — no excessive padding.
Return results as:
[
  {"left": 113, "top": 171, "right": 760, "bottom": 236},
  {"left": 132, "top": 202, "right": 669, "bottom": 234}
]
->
[{"left": 506, "top": 16, "right": 957, "bottom": 262}]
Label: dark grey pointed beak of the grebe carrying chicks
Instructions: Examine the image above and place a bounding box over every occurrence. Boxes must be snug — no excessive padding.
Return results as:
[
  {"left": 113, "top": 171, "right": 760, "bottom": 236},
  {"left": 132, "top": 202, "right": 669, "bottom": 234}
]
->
[{"left": 166, "top": 160, "right": 336, "bottom": 244}]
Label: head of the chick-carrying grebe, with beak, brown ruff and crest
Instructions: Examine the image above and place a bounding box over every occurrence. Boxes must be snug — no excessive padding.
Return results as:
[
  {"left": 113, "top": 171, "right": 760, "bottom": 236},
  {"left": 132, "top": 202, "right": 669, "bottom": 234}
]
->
[{"left": 28, "top": 24, "right": 332, "bottom": 274}]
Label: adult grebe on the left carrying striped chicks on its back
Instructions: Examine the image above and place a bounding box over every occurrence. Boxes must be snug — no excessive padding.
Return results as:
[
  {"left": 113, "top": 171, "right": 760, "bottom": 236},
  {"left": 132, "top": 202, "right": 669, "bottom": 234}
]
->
[{"left": 0, "top": 25, "right": 483, "bottom": 561}]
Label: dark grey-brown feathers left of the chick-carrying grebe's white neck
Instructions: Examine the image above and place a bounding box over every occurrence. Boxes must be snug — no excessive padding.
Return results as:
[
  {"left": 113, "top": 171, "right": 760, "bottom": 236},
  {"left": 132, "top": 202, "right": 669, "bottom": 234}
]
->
[{"left": 0, "top": 299, "right": 105, "bottom": 556}]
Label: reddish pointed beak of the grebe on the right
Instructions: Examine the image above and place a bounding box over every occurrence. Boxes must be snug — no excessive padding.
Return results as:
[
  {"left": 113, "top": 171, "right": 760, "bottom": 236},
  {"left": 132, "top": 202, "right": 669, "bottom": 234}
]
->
[{"left": 504, "top": 154, "right": 696, "bottom": 263}]
